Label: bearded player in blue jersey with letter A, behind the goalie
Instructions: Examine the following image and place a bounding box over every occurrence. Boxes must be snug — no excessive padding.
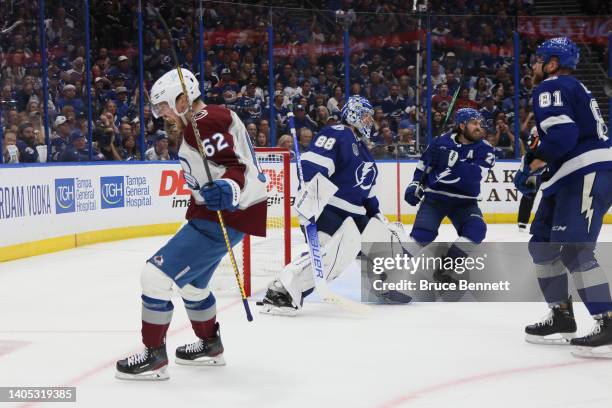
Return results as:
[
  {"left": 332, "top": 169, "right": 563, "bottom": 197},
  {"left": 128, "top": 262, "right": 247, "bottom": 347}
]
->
[{"left": 404, "top": 108, "right": 495, "bottom": 279}]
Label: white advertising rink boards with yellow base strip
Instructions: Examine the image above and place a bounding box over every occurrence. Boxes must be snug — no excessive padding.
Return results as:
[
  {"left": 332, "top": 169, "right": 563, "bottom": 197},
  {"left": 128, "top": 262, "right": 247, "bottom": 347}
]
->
[{"left": 0, "top": 161, "right": 610, "bottom": 261}]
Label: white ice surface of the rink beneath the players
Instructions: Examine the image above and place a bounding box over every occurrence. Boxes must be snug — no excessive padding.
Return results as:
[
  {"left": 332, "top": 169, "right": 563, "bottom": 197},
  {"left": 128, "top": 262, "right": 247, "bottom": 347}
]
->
[{"left": 0, "top": 225, "right": 612, "bottom": 408}]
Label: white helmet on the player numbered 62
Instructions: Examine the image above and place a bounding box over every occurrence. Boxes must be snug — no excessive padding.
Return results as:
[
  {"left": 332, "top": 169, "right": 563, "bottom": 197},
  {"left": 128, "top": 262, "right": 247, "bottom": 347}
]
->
[{"left": 151, "top": 68, "right": 201, "bottom": 118}]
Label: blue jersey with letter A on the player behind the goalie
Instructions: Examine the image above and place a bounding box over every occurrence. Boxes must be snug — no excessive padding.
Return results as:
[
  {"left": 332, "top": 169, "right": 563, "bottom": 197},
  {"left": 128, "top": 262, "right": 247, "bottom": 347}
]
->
[{"left": 413, "top": 132, "right": 495, "bottom": 203}]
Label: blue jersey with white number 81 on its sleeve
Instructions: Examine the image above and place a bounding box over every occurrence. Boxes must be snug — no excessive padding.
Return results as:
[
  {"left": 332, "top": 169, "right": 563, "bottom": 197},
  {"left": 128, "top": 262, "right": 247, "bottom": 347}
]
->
[{"left": 533, "top": 75, "right": 612, "bottom": 196}]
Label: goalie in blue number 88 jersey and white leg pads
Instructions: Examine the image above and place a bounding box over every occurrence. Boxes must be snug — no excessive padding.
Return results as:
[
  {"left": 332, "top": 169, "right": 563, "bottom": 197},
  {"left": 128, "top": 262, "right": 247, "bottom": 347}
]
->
[{"left": 260, "top": 96, "right": 403, "bottom": 315}]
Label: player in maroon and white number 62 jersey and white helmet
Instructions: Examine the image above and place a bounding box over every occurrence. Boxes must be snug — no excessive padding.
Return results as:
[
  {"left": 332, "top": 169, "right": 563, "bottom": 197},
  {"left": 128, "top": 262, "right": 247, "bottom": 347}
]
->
[{"left": 116, "top": 69, "right": 267, "bottom": 380}]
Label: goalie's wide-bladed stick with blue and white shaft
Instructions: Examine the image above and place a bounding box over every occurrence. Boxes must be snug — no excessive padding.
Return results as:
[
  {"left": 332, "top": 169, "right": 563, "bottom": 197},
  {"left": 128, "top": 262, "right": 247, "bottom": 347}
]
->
[{"left": 287, "top": 112, "right": 370, "bottom": 314}]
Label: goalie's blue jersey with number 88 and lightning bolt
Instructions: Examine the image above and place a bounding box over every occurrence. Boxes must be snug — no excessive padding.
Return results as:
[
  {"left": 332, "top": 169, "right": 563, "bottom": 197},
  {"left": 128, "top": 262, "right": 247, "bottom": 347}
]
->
[{"left": 301, "top": 125, "right": 379, "bottom": 217}]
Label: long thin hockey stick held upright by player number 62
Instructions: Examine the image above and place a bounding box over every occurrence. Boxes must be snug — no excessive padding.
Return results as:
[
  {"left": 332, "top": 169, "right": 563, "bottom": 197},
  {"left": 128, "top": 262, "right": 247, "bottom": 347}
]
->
[{"left": 149, "top": 5, "right": 253, "bottom": 322}]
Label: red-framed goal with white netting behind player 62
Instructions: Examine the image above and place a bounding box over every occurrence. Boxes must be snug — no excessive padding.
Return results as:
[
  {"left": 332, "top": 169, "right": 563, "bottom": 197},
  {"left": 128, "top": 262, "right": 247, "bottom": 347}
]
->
[{"left": 211, "top": 147, "right": 291, "bottom": 296}]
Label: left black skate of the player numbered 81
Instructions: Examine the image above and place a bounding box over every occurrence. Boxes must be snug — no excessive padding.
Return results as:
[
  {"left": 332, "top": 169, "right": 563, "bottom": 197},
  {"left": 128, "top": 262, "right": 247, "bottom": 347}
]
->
[{"left": 525, "top": 296, "right": 576, "bottom": 345}]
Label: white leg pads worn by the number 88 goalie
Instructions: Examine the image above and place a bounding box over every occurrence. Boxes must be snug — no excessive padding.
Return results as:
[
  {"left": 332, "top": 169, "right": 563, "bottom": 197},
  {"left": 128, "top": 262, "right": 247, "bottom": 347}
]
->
[{"left": 278, "top": 217, "right": 361, "bottom": 308}]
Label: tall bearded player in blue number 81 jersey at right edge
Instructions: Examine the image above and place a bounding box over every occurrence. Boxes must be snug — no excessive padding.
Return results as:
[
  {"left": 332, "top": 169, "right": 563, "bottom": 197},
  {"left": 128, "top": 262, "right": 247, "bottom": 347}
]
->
[{"left": 514, "top": 37, "right": 612, "bottom": 358}]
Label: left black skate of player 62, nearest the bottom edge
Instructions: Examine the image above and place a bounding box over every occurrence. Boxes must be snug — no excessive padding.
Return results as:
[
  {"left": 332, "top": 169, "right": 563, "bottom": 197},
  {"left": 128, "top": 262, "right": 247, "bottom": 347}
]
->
[{"left": 115, "top": 344, "right": 170, "bottom": 380}]
